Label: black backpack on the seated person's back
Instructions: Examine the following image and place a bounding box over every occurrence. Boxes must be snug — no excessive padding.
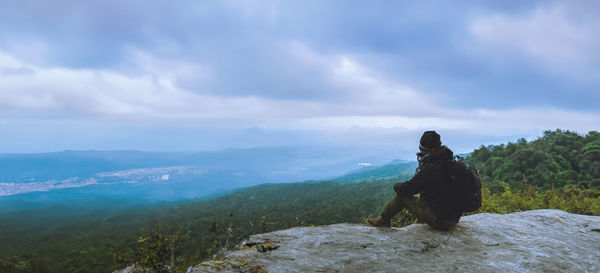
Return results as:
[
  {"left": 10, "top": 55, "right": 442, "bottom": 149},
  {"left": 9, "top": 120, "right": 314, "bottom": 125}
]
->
[{"left": 447, "top": 156, "right": 481, "bottom": 213}]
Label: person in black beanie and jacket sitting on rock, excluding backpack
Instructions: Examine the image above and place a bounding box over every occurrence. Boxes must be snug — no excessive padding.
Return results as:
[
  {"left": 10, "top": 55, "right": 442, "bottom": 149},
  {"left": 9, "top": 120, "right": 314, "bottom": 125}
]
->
[{"left": 367, "top": 131, "right": 462, "bottom": 230}]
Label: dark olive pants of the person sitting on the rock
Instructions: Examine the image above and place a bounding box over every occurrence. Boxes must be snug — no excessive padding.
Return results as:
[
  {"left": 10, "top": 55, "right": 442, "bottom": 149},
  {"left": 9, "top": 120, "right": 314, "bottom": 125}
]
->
[{"left": 381, "top": 194, "right": 460, "bottom": 230}]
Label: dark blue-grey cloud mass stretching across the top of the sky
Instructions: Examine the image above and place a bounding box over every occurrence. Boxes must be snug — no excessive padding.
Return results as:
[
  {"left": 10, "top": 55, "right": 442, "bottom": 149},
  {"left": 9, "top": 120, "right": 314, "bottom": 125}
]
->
[{"left": 0, "top": 0, "right": 599, "bottom": 110}]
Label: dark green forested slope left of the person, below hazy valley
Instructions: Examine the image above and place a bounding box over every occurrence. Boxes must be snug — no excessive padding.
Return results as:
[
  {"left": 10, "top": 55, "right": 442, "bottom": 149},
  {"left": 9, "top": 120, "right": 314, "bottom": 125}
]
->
[{"left": 0, "top": 176, "right": 409, "bottom": 273}]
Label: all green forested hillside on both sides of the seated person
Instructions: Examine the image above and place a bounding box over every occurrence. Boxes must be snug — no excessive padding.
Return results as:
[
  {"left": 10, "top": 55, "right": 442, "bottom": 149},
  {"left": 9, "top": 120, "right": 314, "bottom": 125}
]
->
[{"left": 0, "top": 130, "right": 600, "bottom": 273}]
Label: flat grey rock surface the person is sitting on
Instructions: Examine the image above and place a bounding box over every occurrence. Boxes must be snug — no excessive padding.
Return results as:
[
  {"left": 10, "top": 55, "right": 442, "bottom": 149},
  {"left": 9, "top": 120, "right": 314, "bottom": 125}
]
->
[{"left": 188, "top": 210, "right": 600, "bottom": 272}]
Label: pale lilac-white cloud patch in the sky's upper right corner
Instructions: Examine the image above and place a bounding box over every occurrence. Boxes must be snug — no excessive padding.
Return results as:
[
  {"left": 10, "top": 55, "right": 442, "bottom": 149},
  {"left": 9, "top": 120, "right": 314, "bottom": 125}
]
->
[{"left": 470, "top": 5, "right": 600, "bottom": 63}]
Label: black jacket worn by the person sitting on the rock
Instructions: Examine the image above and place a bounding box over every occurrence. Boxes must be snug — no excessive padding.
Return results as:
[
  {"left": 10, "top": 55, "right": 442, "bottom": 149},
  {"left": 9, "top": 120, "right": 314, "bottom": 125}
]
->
[{"left": 394, "top": 146, "right": 462, "bottom": 220}]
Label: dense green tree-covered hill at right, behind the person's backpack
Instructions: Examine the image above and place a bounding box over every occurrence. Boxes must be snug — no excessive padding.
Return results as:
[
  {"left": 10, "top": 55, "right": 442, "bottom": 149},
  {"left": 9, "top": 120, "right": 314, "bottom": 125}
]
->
[{"left": 469, "top": 130, "right": 600, "bottom": 191}]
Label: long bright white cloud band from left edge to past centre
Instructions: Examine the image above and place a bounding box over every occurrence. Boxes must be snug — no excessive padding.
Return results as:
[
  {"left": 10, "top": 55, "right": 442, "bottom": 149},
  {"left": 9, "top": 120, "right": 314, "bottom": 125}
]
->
[{"left": 0, "top": 43, "right": 430, "bottom": 122}]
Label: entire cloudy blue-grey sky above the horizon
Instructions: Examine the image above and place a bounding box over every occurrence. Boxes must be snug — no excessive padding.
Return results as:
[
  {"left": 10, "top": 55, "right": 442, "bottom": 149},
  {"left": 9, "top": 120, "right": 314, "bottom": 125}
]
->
[{"left": 0, "top": 0, "right": 600, "bottom": 158}]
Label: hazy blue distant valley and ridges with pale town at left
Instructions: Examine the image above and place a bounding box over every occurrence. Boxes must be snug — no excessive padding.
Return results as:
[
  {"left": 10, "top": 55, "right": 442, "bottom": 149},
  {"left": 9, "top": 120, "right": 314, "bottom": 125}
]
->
[{"left": 0, "top": 147, "right": 404, "bottom": 204}]
